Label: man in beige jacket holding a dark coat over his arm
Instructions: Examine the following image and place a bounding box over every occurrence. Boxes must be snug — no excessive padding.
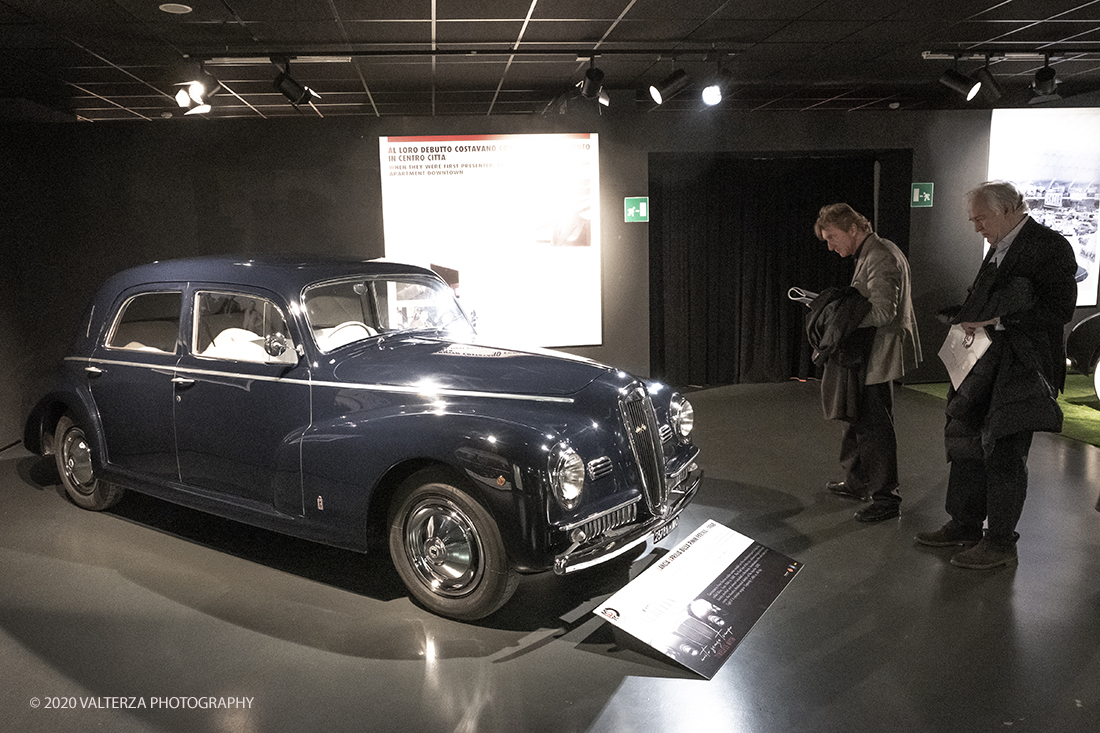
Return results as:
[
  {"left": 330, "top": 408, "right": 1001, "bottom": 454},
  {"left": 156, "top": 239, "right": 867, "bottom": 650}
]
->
[{"left": 814, "top": 204, "right": 921, "bottom": 522}]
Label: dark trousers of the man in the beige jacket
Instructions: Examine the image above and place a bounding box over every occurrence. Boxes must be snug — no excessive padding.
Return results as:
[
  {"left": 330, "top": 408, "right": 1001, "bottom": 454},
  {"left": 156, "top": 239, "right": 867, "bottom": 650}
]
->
[{"left": 840, "top": 382, "right": 901, "bottom": 503}]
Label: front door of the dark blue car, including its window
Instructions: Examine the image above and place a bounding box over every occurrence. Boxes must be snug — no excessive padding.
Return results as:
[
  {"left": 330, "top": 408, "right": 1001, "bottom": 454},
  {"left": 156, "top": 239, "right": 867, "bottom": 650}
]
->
[{"left": 175, "top": 286, "right": 309, "bottom": 515}]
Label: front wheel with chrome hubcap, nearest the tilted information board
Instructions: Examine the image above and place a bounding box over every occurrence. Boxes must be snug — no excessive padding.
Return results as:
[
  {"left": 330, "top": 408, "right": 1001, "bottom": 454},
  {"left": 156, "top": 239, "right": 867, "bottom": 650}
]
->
[{"left": 389, "top": 469, "right": 519, "bottom": 621}]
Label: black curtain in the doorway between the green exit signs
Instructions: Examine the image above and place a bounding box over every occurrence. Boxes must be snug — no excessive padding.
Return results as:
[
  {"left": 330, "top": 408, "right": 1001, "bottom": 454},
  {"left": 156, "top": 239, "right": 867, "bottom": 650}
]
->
[{"left": 649, "top": 151, "right": 912, "bottom": 387}]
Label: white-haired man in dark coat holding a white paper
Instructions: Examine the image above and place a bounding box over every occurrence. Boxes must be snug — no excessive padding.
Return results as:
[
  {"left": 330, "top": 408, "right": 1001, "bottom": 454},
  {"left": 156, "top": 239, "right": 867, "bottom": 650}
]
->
[{"left": 916, "top": 182, "right": 1077, "bottom": 570}]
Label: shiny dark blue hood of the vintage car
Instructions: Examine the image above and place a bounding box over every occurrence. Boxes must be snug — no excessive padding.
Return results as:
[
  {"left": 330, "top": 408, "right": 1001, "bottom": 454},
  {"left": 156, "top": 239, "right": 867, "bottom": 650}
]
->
[{"left": 332, "top": 336, "right": 614, "bottom": 396}]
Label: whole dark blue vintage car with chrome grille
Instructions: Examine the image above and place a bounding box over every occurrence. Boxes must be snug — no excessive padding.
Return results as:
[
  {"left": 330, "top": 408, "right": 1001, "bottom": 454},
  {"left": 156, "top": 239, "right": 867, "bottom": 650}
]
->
[{"left": 25, "top": 258, "right": 702, "bottom": 620}]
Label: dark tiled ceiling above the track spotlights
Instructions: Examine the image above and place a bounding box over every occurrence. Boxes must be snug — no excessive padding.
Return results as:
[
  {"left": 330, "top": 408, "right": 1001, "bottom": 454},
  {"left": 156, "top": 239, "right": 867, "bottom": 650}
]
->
[{"left": 0, "top": 0, "right": 1100, "bottom": 121}]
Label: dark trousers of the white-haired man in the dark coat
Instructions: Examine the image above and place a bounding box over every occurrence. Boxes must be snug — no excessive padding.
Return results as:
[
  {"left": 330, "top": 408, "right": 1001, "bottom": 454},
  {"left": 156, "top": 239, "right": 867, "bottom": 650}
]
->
[{"left": 947, "top": 430, "right": 1033, "bottom": 543}]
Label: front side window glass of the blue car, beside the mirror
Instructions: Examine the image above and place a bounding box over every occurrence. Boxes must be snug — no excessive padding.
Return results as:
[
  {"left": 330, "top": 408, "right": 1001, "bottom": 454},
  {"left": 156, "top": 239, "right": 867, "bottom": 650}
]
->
[{"left": 191, "top": 291, "right": 298, "bottom": 364}]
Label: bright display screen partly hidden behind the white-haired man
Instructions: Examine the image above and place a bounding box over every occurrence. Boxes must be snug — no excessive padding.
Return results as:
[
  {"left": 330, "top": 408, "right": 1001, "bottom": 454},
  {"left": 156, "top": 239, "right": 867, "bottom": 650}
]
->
[{"left": 989, "top": 109, "right": 1100, "bottom": 306}]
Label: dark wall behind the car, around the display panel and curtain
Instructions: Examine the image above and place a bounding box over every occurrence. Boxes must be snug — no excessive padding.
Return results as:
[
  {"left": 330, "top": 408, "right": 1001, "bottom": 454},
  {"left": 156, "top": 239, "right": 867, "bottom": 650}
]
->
[{"left": 0, "top": 108, "right": 1082, "bottom": 448}]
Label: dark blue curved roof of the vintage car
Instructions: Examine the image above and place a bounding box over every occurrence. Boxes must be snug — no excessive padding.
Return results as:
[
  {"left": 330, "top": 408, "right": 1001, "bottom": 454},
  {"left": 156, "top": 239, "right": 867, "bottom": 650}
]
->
[{"left": 101, "top": 255, "right": 439, "bottom": 297}]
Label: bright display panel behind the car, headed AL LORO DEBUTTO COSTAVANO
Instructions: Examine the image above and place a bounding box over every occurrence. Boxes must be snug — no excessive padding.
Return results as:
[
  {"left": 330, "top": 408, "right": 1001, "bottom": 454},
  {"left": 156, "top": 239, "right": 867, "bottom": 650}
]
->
[{"left": 378, "top": 134, "right": 603, "bottom": 347}]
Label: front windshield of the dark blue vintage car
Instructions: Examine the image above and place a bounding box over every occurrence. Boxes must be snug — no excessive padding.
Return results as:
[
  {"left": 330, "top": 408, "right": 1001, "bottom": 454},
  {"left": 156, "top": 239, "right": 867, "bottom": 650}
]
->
[{"left": 303, "top": 276, "right": 473, "bottom": 351}]
